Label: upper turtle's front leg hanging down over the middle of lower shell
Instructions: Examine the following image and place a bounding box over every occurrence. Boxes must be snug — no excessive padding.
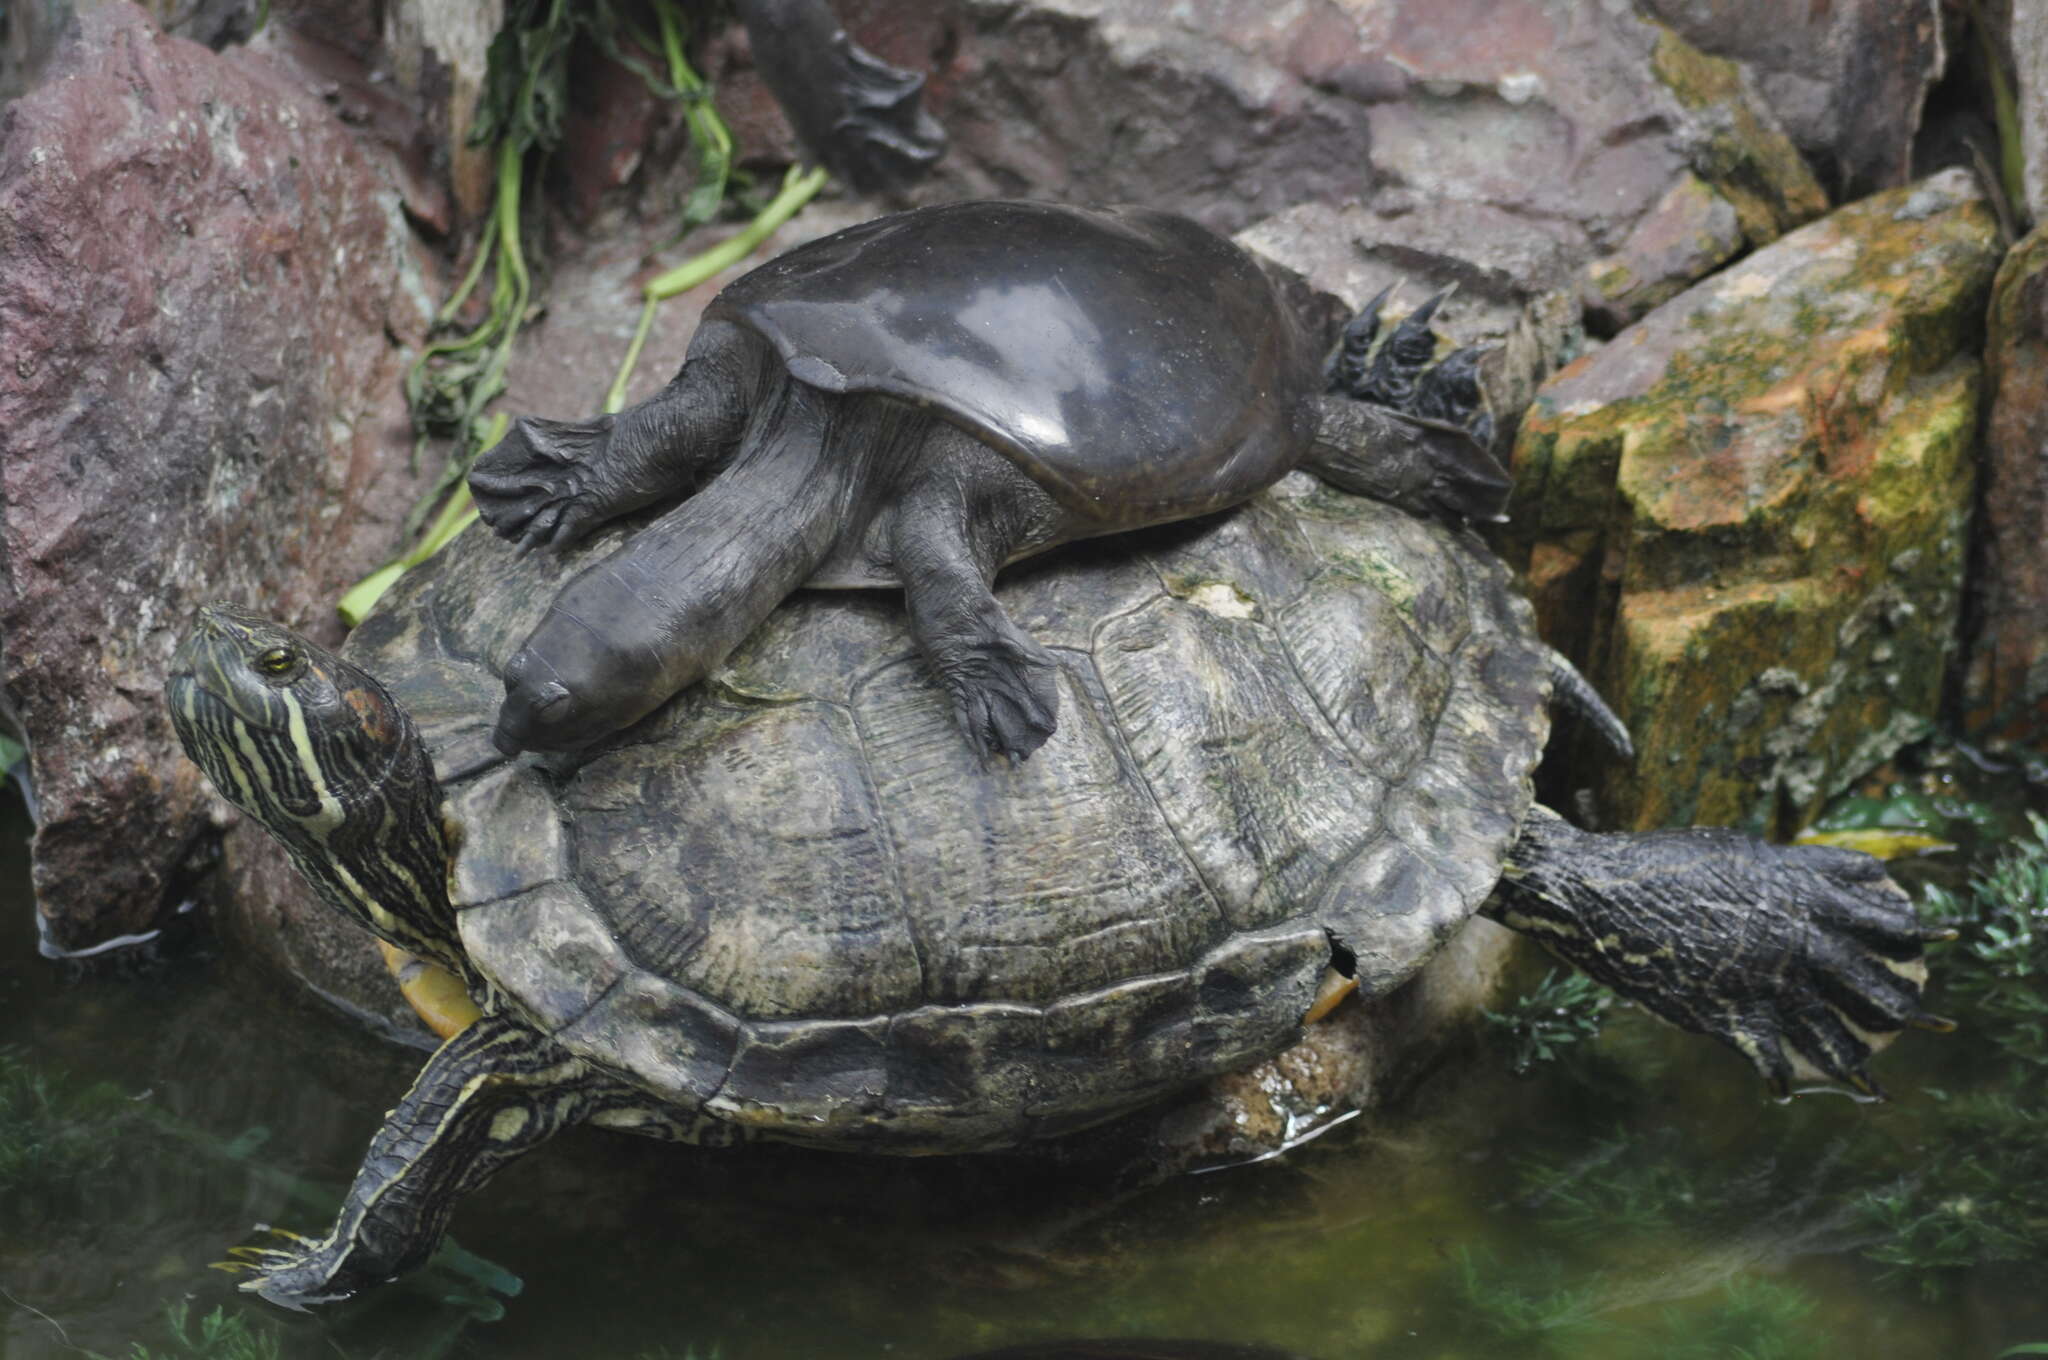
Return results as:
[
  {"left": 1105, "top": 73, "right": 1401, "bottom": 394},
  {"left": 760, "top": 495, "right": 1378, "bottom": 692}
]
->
[{"left": 889, "top": 424, "right": 1065, "bottom": 760}]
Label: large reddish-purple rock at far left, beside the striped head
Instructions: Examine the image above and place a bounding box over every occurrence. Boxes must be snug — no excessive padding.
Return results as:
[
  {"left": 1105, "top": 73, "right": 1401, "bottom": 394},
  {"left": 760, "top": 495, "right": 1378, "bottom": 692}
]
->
[{"left": 0, "top": 4, "right": 430, "bottom": 950}]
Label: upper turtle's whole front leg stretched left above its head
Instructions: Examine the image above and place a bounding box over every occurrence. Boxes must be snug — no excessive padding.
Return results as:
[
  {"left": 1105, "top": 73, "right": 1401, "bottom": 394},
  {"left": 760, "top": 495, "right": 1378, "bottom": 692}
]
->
[{"left": 469, "top": 322, "right": 766, "bottom": 549}]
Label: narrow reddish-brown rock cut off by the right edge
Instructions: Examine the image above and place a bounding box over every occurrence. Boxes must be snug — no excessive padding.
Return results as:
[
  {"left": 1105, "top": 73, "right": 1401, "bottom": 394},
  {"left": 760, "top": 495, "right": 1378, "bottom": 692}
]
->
[{"left": 1966, "top": 227, "right": 2048, "bottom": 737}]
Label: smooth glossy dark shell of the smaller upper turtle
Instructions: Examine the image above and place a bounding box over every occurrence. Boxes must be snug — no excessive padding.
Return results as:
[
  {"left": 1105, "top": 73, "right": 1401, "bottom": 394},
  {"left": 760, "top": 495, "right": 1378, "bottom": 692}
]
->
[{"left": 707, "top": 201, "right": 1321, "bottom": 526}]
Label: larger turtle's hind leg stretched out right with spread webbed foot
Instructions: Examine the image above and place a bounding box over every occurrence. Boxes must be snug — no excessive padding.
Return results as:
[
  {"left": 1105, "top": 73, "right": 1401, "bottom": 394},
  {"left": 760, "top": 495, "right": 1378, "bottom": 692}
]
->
[{"left": 1489, "top": 807, "right": 1948, "bottom": 1096}]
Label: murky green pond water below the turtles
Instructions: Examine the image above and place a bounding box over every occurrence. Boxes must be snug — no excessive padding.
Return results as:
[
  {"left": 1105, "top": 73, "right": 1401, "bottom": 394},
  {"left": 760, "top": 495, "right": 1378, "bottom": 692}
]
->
[{"left": 0, "top": 753, "right": 2048, "bottom": 1360}]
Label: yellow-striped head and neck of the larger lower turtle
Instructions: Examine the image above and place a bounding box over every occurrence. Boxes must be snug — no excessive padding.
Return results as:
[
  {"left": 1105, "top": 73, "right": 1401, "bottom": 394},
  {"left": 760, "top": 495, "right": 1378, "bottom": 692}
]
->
[{"left": 164, "top": 604, "right": 461, "bottom": 961}]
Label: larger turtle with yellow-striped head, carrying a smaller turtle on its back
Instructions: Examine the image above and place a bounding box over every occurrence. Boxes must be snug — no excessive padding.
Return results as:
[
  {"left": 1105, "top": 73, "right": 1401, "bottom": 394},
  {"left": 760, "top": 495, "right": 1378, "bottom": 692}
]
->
[{"left": 168, "top": 473, "right": 1935, "bottom": 1303}]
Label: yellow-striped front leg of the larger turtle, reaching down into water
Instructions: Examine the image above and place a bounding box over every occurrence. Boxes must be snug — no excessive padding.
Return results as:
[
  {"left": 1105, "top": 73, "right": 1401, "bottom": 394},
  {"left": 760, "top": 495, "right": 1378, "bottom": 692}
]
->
[{"left": 221, "top": 1016, "right": 626, "bottom": 1309}]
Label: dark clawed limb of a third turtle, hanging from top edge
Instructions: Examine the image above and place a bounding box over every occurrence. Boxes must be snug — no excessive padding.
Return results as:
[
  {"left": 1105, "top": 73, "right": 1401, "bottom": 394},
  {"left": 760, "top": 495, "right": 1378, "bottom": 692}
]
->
[{"left": 737, "top": 0, "right": 946, "bottom": 195}]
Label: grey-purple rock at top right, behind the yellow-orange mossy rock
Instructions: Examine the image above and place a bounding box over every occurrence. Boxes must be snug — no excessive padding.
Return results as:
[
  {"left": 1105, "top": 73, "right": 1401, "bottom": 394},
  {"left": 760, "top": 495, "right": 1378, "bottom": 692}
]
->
[{"left": 1642, "top": 0, "right": 1941, "bottom": 199}]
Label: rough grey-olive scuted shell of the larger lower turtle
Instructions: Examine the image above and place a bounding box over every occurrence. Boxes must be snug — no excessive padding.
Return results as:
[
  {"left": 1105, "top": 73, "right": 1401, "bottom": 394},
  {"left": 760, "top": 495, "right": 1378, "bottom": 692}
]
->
[{"left": 348, "top": 473, "right": 1548, "bottom": 1151}]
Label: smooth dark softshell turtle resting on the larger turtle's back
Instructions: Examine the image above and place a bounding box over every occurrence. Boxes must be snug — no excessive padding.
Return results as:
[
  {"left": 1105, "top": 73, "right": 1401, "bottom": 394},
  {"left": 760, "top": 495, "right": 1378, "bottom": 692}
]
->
[{"left": 469, "top": 201, "right": 1507, "bottom": 758}]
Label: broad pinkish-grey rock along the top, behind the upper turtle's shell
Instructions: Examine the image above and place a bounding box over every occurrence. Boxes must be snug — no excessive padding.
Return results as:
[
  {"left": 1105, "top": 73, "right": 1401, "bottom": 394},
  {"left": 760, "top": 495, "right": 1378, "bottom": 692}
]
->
[{"left": 719, "top": 0, "right": 1825, "bottom": 276}]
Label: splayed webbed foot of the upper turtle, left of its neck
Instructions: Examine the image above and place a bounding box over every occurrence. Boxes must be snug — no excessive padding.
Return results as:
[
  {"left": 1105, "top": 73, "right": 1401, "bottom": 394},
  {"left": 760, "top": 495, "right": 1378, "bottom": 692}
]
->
[{"left": 469, "top": 416, "right": 612, "bottom": 553}]
